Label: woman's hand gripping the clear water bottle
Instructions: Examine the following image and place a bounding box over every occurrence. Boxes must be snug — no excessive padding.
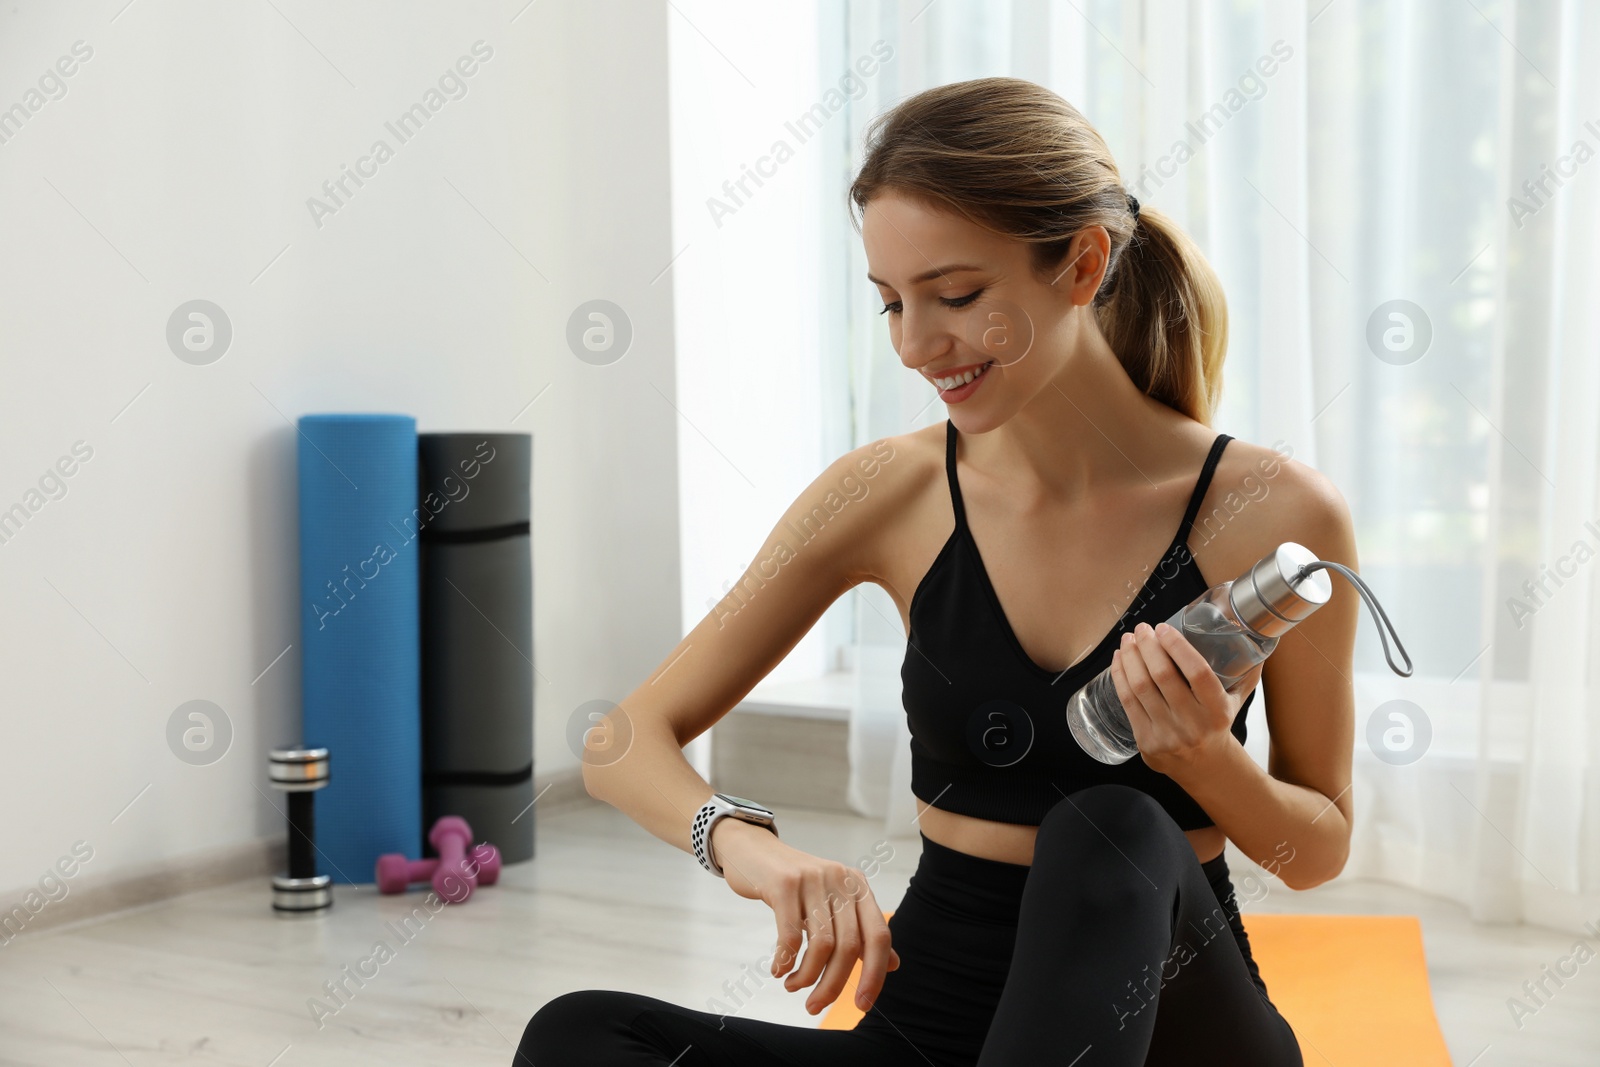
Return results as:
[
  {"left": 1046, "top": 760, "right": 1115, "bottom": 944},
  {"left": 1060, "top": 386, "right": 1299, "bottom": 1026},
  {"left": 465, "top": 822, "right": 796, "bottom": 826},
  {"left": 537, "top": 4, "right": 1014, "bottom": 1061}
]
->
[{"left": 1110, "top": 622, "right": 1266, "bottom": 776}]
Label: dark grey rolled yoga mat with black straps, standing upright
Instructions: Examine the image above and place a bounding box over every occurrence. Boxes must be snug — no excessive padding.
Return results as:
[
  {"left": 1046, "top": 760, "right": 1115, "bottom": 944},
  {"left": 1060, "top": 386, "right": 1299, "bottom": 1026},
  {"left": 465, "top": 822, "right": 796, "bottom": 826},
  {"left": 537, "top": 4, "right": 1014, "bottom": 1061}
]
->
[{"left": 418, "top": 434, "right": 534, "bottom": 862}]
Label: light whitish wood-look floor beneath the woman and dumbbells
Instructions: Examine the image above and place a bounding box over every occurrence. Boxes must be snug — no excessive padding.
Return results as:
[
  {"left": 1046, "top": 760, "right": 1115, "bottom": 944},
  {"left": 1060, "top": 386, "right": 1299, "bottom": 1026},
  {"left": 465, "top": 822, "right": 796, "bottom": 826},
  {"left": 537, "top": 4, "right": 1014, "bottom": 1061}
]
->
[{"left": 0, "top": 805, "right": 1600, "bottom": 1067}]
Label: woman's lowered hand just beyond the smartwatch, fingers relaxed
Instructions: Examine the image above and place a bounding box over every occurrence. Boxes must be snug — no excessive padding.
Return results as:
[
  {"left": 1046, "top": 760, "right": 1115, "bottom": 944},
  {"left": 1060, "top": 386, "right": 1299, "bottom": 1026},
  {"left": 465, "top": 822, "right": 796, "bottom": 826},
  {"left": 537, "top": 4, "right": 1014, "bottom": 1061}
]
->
[{"left": 710, "top": 819, "right": 899, "bottom": 1014}]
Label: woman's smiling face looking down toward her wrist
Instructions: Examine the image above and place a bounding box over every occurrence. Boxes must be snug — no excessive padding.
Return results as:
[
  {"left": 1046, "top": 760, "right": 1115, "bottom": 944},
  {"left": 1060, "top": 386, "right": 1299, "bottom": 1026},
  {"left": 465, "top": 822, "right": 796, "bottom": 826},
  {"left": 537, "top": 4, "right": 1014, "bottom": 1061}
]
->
[{"left": 861, "top": 190, "right": 1109, "bottom": 432}]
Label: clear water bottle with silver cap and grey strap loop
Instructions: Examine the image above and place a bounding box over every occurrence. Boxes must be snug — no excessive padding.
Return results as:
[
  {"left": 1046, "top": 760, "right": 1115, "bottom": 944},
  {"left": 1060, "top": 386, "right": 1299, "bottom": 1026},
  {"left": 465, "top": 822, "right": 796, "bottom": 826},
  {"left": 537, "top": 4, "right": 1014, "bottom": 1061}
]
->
[{"left": 1067, "top": 541, "right": 1411, "bottom": 763}]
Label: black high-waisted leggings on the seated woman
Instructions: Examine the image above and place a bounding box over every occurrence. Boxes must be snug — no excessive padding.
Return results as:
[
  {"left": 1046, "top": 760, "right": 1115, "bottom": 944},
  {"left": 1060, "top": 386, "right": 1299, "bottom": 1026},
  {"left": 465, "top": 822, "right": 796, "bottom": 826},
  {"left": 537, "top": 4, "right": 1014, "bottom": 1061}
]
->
[{"left": 514, "top": 785, "right": 1302, "bottom": 1067}]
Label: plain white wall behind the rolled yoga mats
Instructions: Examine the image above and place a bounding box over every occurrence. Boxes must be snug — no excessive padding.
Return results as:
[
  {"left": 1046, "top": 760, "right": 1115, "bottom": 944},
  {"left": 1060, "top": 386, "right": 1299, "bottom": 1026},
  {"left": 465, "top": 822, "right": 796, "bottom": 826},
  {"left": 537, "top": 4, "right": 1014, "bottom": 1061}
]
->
[{"left": 0, "top": 0, "right": 682, "bottom": 905}]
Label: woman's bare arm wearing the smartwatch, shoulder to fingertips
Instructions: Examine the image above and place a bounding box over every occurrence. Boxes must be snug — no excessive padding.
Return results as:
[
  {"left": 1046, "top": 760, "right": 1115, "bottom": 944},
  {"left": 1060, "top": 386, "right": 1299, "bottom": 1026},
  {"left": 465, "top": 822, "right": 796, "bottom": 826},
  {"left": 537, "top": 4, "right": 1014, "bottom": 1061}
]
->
[{"left": 584, "top": 438, "right": 915, "bottom": 1014}]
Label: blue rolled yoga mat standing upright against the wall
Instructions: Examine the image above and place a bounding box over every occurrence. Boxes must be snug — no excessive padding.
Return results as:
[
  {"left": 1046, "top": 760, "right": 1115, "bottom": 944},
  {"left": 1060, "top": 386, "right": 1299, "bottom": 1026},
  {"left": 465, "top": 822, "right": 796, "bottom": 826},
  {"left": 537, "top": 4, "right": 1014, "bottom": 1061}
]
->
[{"left": 298, "top": 414, "right": 422, "bottom": 885}]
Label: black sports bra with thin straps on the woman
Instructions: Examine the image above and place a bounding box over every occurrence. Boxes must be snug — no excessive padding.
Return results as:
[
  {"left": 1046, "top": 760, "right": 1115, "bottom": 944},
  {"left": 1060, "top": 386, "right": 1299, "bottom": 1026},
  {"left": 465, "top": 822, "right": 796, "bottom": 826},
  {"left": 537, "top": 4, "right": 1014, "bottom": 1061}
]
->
[{"left": 901, "top": 421, "right": 1256, "bottom": 830}]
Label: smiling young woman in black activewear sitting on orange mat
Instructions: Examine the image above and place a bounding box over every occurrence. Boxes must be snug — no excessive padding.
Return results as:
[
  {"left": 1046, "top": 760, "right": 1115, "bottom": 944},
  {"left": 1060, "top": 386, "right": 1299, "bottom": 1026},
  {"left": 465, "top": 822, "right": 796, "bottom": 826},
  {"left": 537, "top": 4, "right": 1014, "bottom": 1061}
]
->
[{"left": 517, "top": 78, "right": 1357, "bottom": 1067}]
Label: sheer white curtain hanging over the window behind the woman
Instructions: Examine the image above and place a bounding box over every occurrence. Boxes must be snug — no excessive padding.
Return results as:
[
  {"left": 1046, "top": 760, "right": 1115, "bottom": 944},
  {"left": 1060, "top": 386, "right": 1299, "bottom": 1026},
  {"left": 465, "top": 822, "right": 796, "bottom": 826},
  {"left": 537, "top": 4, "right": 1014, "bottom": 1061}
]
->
[{"left": 824, "top": 0, "right": 1600, "bottom": 929}]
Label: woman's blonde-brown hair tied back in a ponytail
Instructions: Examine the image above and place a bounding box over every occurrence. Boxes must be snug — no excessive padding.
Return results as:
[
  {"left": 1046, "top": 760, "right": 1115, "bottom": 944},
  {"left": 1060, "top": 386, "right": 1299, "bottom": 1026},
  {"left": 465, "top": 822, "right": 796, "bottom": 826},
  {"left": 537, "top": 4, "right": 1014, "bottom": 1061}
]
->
[{"left": 850, "top": 78, "right": 1227, "bottom": 426}]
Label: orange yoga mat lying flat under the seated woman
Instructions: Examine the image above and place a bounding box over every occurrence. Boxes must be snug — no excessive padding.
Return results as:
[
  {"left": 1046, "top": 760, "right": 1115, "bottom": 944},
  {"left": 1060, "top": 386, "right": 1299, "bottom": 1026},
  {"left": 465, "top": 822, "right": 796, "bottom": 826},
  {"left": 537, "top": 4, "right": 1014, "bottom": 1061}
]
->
[{"left": 821, "top": 912, "right": 1450, "bottom": 1067}]
